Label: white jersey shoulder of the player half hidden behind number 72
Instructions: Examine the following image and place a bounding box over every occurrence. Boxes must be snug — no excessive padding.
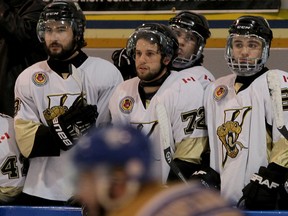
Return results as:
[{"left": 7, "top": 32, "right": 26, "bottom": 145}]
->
[{"left": 179, "top": 66, "right": 215, "bottom": 89}]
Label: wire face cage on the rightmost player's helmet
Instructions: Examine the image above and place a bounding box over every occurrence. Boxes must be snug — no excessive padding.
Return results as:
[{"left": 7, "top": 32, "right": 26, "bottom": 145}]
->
[{"left": 225, "top": 34, "right": 270, "bottom": 76}]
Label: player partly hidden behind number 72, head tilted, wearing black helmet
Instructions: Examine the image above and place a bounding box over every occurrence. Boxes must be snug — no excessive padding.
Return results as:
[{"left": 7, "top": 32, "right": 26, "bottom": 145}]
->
[{"left": 169, "top": 11, "right": 215, "bottom": 88}]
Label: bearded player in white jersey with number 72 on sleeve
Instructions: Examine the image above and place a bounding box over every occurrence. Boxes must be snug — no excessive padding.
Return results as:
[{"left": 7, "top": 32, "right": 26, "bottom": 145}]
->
[{"left": 109, "top": 23, "right": 207, "bottom": 183}]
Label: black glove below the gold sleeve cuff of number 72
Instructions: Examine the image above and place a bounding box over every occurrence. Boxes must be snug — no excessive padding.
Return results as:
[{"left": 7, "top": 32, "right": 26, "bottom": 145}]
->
[{"left": 190, "top": 166, "right": 221, "bottom": 190}]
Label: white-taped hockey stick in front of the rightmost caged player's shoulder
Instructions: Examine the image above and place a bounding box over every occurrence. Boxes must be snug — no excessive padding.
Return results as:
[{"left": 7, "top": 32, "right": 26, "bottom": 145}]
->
[{"left": 267, "top": 70, "right": 288, "bottom": 139}]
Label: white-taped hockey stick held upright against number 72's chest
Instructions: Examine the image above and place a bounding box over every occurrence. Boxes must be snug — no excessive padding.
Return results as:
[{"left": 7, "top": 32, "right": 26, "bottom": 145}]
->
[{"left": 156, "top": 103, "right": 187, "bottom": 184}]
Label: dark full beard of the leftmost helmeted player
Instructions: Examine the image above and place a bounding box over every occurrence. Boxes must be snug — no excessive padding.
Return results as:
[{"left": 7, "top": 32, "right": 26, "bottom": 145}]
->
[{"left": 45, "top": 40, "right": 77, "bottom": 60}]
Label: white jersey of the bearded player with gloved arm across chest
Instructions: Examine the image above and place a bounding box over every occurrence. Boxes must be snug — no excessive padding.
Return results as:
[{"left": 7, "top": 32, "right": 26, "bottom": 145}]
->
[{"left": 15, "top": 57, "right": 123, "bottom": 201}]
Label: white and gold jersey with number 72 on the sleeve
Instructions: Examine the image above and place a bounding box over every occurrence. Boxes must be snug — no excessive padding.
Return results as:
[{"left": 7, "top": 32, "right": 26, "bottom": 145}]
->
[{"left": 109, "top": 72, "right": 207, "bottom": 183}]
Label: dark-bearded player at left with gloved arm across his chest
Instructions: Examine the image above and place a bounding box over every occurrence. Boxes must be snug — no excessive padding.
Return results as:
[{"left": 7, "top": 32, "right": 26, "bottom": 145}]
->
[{"left": 15, "top": 1, "right": 123, "bottom": 205}]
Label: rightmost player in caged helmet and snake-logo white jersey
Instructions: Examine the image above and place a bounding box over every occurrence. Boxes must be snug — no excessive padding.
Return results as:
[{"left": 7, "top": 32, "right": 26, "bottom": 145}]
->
[{"left": 204, "top": 15, "right": 288, "bottom": 210}]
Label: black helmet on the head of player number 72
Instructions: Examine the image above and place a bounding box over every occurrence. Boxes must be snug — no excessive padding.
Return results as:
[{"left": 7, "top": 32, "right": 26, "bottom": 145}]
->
[{"left": 126, "top": 25, "right": 178, "bottom": 60}]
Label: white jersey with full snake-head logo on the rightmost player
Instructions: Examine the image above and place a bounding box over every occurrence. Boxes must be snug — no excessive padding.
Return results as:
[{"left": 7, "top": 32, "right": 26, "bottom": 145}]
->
[{"left": 204, "top": 70, "right": 288, "bottom": 205}]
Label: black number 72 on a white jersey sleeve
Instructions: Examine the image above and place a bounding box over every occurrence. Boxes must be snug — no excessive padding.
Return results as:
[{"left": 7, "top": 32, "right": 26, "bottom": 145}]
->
[{"left": 181, "top": 107, "right": 207, "bottom": 134}]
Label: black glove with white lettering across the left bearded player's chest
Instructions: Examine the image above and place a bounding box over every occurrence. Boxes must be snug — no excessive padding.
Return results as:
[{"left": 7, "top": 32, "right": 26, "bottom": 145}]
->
[{"left": 50, "top": 96, "right": 98, "bottom": 151}]
